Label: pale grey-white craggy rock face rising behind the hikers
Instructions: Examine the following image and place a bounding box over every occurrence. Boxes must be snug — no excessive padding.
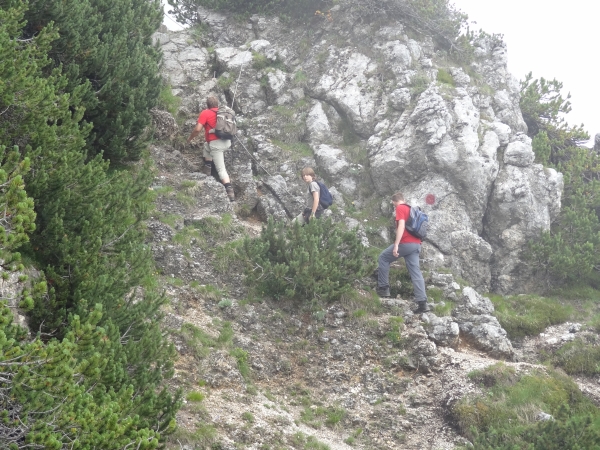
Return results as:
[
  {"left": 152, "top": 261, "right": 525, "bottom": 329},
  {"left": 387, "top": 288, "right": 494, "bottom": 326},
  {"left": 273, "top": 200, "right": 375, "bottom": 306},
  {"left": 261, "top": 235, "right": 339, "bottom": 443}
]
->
[{"left": 154, "top": 16, "right": 563, "bottom": 293}]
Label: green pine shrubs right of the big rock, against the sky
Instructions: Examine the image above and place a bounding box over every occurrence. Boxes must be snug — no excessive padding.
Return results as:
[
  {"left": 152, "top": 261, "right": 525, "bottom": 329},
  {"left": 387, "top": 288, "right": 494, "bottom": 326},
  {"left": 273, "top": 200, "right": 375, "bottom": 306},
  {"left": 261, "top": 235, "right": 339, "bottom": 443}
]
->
[{"left": 521, "top": 74, "right": 600, "bottom": 287}]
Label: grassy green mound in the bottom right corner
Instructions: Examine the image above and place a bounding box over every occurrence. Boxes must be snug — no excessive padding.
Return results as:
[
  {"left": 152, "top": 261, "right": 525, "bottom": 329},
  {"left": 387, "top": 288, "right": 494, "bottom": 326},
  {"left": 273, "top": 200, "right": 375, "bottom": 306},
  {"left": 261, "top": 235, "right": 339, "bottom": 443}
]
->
[{"left": 453, "top": 363, "right": 600, "bottom": 450}]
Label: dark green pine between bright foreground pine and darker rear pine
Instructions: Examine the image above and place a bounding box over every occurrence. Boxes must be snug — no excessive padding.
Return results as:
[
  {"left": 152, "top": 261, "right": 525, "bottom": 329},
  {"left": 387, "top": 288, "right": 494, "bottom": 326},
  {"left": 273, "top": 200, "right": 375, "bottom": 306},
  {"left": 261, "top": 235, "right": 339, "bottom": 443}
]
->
[{"left": 0, "top": 2, "right": 179, "bottom": 440}]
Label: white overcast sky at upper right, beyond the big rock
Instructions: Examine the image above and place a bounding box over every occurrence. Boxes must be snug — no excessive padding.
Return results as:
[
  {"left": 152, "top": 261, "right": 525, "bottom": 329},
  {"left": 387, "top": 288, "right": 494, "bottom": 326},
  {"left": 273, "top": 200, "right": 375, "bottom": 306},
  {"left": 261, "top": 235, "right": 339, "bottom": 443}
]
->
[{"left": 452, "top": 0, "right": 600, "bottom": 140}]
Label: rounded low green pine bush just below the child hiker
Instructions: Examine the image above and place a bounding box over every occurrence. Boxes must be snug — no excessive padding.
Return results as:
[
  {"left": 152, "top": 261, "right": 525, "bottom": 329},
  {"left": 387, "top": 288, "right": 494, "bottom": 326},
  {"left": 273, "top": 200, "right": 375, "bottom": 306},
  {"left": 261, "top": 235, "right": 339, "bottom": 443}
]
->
[{"left": 244, "top": 219, "right": 365, "bottom": 301}]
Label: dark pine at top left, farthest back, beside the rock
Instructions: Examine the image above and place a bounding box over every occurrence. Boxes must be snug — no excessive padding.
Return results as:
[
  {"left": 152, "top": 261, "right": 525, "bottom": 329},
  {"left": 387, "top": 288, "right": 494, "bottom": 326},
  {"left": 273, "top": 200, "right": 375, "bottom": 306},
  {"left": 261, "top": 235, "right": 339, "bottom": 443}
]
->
[{"left": 25, "top": 0, "right": 162, "bottom": 163}]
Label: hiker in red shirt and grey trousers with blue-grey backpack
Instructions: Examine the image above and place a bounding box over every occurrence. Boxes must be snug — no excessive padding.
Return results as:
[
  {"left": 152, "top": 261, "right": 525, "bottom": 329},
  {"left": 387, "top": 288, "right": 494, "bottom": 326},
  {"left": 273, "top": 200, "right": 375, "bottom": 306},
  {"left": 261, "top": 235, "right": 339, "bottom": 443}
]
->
[{"left": 377, "top": 193, "right": 430, "bottom": 313}]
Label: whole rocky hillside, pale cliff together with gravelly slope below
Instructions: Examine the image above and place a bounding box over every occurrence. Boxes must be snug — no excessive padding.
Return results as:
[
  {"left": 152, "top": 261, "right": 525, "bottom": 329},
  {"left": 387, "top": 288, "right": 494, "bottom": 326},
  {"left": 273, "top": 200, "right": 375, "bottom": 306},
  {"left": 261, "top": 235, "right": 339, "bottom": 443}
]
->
[{"left": 148, "top": 7, "right": 597, "bottom": 449}]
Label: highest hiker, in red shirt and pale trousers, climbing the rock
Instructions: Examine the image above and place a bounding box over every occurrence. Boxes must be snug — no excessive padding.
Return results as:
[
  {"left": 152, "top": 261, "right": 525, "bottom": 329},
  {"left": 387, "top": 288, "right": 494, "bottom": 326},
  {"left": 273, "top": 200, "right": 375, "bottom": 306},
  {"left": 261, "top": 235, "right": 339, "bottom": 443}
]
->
[{"left": 187, "top": 96, "right": 236, "bottom": 201}]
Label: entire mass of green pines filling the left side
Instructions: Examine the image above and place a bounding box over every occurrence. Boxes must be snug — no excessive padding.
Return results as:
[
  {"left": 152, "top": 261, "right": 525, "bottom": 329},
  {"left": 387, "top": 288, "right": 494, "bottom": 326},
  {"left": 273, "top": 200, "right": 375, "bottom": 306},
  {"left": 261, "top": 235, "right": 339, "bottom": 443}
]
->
[{"left": 0, "top": 0, "right": 180, "bottom": 449}]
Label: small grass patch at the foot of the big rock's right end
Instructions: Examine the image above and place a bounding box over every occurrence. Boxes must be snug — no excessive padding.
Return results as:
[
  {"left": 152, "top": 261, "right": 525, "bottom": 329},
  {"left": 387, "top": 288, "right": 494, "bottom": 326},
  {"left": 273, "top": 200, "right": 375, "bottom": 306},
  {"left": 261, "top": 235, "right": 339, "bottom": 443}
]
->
[{"left": 490, "top": 295, "right": 573, "bottom": 339}]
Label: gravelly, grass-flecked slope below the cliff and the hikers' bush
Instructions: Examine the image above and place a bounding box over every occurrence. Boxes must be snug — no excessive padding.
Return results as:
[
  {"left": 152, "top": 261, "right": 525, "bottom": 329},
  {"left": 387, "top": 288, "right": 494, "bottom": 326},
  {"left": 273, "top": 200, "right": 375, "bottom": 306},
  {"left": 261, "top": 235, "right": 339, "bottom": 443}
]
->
[{"left": 148, "top": 126, "right": 598, "bottom": 450}]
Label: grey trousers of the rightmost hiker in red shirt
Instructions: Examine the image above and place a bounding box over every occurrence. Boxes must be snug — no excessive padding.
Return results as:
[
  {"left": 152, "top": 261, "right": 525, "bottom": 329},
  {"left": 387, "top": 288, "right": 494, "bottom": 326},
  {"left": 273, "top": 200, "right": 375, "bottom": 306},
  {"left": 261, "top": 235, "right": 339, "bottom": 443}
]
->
[{"left": 377, "top": 244, "right": 427, "bottom": 302}]
